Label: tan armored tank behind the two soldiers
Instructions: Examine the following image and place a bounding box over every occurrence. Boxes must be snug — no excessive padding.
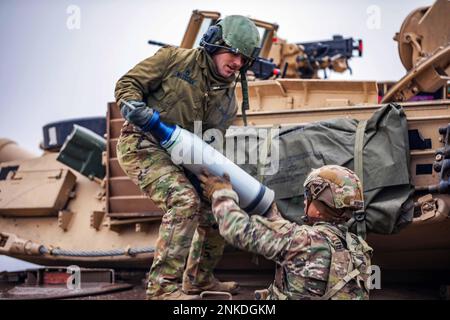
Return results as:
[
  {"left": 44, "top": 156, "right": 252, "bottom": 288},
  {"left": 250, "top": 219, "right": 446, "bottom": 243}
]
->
[{"left": 0, "top": 0, "right": 450, "bottom": 288}]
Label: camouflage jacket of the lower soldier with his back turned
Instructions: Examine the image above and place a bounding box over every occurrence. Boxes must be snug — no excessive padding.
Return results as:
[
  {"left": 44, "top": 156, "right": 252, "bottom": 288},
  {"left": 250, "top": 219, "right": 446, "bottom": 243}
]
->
[{"left": 212, "top": 190, "right": 372, "bottom": 299}]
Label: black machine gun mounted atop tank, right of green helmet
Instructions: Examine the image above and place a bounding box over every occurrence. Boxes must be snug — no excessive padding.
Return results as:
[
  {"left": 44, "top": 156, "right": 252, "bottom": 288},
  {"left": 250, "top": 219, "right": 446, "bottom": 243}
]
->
[{"left": 296, "top": 35, "right": 363, "bottom": 79}]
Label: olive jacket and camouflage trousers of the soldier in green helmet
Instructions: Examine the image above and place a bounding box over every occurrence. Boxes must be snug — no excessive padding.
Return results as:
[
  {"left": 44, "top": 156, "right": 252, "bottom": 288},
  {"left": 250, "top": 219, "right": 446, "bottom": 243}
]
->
[{"left": 115, "top": 47, "right": 236, "bottom": 296}]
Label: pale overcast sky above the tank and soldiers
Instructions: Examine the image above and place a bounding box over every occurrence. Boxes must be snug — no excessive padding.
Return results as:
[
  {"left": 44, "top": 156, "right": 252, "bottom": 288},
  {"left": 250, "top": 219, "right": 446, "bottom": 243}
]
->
[{"left": 0, "top": 0, "right": 433, "bottom": 154}]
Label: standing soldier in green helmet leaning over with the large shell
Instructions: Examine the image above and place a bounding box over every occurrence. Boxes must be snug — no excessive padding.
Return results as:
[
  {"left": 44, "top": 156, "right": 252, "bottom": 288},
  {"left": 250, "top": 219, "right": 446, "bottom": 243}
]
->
[{"left": 115, "top": 15, "right": 260, "bottom": 299}]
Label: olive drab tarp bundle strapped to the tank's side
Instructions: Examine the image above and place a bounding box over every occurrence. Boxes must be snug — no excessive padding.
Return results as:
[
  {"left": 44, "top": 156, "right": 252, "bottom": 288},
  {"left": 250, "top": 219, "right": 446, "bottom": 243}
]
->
[{"left": 227, "top": 104, "right": 414, "bottom": 234}]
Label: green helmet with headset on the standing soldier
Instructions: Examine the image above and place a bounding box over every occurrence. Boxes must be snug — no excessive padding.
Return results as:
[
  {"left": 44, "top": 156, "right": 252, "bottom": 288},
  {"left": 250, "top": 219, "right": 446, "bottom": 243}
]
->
[{"left": 200, "top": 15, "right": 261, "bottom": 63}]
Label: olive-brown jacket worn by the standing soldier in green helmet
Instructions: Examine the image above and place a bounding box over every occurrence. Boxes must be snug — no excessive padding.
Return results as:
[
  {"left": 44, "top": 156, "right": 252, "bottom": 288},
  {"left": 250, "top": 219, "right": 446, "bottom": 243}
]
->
[{"left": 115, "top": 46, "right": 237, "bottom": 132}]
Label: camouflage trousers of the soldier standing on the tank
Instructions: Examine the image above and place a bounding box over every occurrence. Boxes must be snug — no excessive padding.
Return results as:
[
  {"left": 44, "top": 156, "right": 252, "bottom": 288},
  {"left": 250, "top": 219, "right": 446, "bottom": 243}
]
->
[{"left": 117, "top": 125, "right": 225, "bottom": 296}]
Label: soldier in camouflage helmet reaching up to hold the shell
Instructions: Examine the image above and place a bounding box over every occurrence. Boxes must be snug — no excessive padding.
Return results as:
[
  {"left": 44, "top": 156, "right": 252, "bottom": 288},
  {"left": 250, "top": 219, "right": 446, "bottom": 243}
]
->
[{"left": 200, "top": 165, "right": 372, "bottom": 300}]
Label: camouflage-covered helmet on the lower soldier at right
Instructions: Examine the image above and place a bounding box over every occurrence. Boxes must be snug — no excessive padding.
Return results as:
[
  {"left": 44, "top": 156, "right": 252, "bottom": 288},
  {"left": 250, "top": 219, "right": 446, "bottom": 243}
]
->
[{"left": 303, "top": 165, "right": 364, "bottom": 220}]
